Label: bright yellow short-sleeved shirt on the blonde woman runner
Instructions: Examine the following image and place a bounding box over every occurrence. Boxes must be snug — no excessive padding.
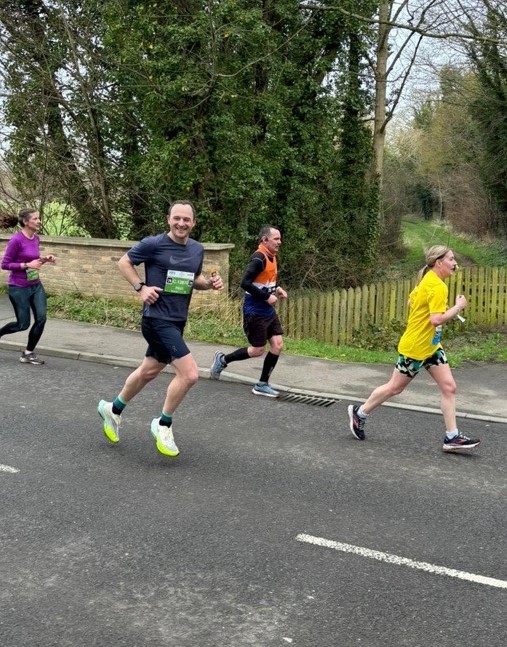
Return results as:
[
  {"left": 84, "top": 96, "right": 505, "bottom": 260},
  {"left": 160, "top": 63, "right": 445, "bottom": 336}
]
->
[{"left": 398, "top": 270, "right": 448, "bottom": 360}]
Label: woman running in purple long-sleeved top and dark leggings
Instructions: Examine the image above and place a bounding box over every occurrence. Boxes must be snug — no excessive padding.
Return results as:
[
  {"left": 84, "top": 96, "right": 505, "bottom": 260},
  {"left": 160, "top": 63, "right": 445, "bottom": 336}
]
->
[{"left": 0, "top": 209, "right": 55, "bottom": 364}]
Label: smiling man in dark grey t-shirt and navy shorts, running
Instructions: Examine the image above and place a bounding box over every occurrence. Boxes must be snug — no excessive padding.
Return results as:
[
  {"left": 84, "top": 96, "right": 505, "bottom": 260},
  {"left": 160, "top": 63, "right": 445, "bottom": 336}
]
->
[{"left": 97, "top": 200, "right": 223, "bottom": 457}]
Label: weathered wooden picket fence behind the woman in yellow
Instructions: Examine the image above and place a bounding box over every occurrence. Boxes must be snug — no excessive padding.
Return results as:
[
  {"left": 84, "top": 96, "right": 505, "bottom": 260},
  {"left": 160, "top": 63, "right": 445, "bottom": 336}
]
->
[{"left": 278, "top": 267, "right": 507, "bottom": 344}]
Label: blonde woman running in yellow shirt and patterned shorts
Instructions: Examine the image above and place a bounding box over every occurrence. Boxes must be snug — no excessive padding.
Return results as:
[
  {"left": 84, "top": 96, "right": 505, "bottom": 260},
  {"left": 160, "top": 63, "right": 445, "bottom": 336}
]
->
[{"left": 348, "top": 245, "right": 480, "bottom": 452}]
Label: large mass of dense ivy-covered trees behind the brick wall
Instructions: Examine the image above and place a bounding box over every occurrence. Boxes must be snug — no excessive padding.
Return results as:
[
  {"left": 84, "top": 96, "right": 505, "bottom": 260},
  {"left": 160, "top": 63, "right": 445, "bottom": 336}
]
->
[{"left": 0, "top": 0, "right": 379, "bottom": 288}]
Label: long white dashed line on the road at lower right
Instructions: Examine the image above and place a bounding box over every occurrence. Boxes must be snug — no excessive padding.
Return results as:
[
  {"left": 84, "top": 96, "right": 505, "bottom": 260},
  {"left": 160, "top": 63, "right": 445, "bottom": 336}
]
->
[{"left": 296, "top": 533, "right": 507, "bottom": 589}]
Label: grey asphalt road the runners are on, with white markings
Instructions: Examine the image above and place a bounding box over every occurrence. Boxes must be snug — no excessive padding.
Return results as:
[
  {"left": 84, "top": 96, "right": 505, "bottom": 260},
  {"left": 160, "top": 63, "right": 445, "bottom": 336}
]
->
[{"left": 0, "top": 351, "right": 507, "bottom": 647}]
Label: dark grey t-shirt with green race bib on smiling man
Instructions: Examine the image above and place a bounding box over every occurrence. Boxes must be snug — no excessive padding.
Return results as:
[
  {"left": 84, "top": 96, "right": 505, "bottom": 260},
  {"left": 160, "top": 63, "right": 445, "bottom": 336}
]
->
[{"left": 127, "top": 234, "right": 204, "bottom": 321}]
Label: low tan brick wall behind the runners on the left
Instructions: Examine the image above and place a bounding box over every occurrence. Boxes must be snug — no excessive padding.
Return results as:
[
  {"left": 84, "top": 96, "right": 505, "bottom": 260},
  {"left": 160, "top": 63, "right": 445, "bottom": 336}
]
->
[{"left": 0, "top": 233, "right": 234, "bottom": 309}]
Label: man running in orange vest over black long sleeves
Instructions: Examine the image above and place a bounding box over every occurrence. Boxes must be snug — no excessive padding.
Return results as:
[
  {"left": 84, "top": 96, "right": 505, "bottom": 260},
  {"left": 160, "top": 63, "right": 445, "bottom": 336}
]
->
[{"left": 210, "top": 225, "right": 287, "bottom": 398}]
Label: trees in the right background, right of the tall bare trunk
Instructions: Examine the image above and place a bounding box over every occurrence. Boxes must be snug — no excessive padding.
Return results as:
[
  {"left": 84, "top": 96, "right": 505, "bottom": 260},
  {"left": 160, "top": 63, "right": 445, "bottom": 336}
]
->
[{"left": 385, "top": 49, "right": 507, "bottom": 244}]
